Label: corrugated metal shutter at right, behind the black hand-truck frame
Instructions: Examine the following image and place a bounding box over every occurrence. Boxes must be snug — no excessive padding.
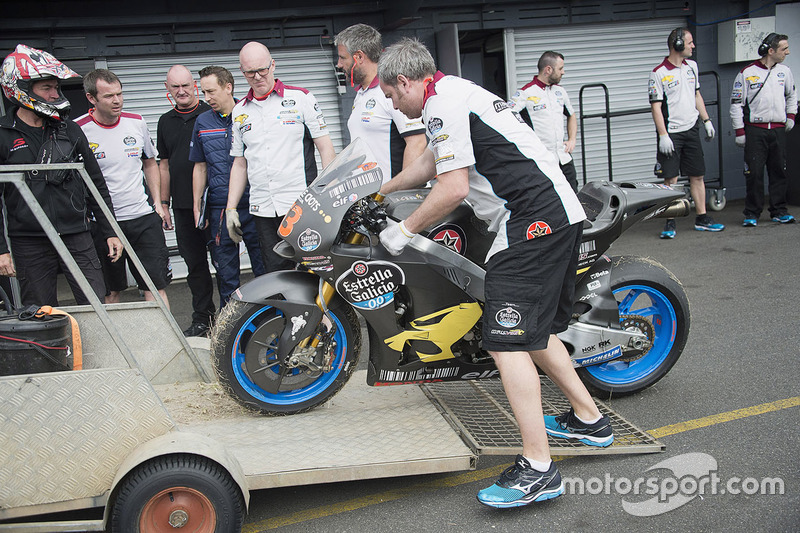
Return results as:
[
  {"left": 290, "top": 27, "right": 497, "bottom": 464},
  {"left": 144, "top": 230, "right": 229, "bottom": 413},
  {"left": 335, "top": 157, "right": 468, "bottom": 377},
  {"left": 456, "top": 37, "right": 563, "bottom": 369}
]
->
[{"left": 505, "top": 18, "right": 688, "bottom": 183}]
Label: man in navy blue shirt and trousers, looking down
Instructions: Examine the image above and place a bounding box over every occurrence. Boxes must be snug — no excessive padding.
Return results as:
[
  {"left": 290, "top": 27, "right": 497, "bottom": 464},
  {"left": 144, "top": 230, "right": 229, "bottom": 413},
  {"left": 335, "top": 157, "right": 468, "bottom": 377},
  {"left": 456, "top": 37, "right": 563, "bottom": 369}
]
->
[{"left": 189, "top": 66, "right": 265, "bottom": 308}]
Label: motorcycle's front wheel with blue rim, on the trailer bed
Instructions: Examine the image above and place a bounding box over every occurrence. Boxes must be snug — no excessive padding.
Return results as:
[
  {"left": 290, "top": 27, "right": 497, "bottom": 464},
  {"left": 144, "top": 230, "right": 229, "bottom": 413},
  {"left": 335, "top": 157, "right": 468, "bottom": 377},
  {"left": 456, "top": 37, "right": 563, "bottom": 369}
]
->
[{"left": 211, "top": 299, "right": 361, "bottom": 415}]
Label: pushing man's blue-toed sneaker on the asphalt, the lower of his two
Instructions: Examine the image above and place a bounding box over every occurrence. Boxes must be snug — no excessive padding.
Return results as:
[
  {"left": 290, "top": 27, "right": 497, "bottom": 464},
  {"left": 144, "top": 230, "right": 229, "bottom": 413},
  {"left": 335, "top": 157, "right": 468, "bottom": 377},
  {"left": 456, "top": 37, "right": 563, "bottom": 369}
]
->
[{"left": 478, "top": 455, "right": 564, "bottom": 509}]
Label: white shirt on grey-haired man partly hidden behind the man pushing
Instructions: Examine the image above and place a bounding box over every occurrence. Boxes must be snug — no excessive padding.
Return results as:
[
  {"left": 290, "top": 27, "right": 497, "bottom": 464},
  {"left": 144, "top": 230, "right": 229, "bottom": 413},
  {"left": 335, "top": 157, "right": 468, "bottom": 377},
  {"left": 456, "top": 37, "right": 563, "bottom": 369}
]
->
[{"left": 347, "top": 76, "right": 425, "bottom": 183}]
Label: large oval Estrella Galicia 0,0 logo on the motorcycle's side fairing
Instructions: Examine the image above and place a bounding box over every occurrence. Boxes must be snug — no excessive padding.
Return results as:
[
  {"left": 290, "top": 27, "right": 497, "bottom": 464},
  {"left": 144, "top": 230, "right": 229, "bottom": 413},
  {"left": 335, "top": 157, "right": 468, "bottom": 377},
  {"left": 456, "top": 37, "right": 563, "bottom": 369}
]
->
[{"left": 336, "top": 261, "right": 406, "bottom": 310}]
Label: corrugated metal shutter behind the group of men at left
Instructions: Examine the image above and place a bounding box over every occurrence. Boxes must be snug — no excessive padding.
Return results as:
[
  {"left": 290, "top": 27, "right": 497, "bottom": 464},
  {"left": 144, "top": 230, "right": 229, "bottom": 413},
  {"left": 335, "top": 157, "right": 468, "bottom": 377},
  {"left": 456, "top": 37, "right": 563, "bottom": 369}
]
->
[{"left": 102, "top": 48, "right": 342, "bottom": 278}]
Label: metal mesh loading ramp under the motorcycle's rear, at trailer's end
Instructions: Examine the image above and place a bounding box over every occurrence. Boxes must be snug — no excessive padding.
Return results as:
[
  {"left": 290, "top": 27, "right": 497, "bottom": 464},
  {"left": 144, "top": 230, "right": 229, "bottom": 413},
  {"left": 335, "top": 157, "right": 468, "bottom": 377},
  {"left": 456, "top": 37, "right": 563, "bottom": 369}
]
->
[{"left": 420, "top": 376, "right": 666, "bottom": 455}]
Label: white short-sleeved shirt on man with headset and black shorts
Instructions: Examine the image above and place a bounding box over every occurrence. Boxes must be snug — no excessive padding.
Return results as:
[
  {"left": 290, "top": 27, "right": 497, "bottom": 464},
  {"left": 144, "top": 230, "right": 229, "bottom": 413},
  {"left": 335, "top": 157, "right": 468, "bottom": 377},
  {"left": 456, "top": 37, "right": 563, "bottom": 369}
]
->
[{"left": 648, "top": 58, "right": 700, "bottom": 133}]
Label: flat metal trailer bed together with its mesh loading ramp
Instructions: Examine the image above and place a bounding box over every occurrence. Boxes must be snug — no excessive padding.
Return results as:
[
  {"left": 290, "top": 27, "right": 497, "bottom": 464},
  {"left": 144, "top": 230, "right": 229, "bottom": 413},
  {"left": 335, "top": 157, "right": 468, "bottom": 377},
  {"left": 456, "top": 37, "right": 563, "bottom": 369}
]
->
[{"left": 155, "top": 370, "right": 665, "bottom": 490}]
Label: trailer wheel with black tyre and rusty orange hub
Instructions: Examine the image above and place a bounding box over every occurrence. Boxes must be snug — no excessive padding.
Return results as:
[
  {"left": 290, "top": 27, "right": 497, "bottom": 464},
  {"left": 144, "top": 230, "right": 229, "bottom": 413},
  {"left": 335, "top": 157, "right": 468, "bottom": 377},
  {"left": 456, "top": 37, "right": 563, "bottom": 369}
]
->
[{"left": 110, "top": 455, "right": 245, "bottom": 533}]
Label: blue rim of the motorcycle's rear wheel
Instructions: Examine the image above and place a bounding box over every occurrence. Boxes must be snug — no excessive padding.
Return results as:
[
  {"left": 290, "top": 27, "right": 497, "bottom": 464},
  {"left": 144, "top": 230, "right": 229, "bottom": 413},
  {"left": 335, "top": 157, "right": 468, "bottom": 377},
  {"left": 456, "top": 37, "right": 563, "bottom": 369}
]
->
[{"left": 586, "top": 285, "right": 678, "bottom": 385}]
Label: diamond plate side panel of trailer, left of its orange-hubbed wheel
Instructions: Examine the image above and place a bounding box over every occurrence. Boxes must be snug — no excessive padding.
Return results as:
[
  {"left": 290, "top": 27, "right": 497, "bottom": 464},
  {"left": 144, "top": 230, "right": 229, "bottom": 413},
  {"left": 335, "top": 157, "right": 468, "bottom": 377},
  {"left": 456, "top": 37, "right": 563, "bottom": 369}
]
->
[{"left": 0, "top": 369, "right": 173, "bottom": 510}]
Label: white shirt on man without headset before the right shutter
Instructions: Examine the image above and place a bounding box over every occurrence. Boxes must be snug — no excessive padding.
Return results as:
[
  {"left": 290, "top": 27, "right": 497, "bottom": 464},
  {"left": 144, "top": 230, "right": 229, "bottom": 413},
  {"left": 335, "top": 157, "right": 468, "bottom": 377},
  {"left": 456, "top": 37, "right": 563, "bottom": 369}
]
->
[{"left": 509, "top": 78, "right": 575, "bottom": 165}]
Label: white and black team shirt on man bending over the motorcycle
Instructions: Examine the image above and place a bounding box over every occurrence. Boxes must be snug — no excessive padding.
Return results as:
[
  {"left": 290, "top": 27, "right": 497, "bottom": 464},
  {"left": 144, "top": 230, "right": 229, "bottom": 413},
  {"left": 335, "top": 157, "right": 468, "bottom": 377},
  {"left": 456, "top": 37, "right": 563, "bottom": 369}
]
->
[{"left": 422, "top": 72, "right": 586, "bottom": 261}]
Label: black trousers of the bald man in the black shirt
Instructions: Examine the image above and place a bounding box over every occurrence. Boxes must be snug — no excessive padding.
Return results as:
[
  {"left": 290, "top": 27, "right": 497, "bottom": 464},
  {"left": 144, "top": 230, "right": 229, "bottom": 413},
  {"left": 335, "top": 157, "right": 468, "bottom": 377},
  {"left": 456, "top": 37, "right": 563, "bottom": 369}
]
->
[{"left": 172, "top": 208, "right": 216, "bottom": 324}]
